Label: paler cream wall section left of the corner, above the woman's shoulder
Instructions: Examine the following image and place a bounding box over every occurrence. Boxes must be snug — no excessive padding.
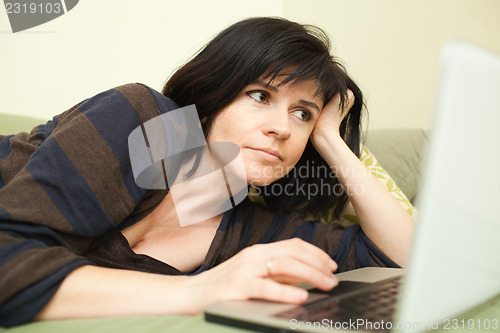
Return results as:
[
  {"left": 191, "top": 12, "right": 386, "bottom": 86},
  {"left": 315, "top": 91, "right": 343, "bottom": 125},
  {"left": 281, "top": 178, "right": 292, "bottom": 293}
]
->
[{"left": 0, "top": 0, "right": 284, "bottom": 118}]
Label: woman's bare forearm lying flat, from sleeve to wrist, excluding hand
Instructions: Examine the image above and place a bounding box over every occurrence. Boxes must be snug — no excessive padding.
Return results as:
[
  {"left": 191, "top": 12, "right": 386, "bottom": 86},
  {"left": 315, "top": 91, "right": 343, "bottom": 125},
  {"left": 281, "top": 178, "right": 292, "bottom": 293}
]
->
[{"left": 35, "top": 266, "right": 201, "bottom": 320}]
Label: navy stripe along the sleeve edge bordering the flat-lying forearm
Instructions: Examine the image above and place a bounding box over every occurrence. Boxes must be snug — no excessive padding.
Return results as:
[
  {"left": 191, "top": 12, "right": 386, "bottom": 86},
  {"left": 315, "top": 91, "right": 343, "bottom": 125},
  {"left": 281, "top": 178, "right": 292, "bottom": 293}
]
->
[{"left": 0, "top": 259, "right": 91, "bottom": 327}]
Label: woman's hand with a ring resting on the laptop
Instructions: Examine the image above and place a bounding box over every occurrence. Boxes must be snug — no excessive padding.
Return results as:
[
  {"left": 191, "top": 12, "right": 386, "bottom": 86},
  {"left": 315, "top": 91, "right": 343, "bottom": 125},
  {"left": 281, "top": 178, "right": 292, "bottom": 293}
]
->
[{"left": 185, "top": 238, "right": 338, "bottom": 314}]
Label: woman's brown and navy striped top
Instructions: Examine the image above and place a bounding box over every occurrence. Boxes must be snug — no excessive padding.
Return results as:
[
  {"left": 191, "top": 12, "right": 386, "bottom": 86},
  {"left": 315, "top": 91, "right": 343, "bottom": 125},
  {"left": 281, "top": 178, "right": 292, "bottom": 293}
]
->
[{"left": 0, "top": 84, "right": 397, "bottom": 326}]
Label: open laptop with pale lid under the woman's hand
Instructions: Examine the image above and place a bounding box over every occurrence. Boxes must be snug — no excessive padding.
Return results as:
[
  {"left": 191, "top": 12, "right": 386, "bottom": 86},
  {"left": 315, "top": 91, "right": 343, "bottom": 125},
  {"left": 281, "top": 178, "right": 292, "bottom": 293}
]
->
[{"left": 205, "top": 40, "right": 500, "bottom": 332}]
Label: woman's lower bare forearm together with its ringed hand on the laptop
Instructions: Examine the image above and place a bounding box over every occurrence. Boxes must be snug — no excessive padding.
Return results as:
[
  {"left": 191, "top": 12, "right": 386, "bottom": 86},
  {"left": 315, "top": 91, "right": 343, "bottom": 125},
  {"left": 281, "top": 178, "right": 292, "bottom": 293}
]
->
[{"left": 34, "top": 238, "right": 337, "bottom": 320}]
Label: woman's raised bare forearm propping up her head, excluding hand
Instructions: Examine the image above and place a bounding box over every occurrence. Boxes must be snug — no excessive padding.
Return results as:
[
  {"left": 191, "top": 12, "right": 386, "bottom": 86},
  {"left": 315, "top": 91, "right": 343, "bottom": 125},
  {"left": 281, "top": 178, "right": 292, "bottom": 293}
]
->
[{"left": 322, "top": 136, "right": 413, "bottom": 266}]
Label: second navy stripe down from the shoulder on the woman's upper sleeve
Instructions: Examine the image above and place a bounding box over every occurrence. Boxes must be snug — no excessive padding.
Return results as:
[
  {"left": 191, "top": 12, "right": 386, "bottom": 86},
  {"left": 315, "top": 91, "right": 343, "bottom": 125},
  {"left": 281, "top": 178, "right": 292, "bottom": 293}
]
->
[{"left": 25, "top": 137, "right": 113, "bottom": 237}]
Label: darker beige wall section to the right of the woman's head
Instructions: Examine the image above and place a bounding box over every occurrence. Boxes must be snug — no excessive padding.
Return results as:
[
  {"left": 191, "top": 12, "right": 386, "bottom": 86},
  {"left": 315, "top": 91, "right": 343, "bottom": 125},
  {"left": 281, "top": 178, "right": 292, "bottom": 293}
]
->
[{"left": 285, "top": 0, "right": 500, "bottom": 128}]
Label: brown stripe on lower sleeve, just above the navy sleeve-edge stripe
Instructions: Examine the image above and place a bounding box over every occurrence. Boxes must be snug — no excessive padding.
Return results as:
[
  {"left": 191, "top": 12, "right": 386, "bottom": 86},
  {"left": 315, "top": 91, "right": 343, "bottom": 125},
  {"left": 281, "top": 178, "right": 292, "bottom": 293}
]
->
[{"left": 0, "top": 246, "right": 78, "bottom": 304}]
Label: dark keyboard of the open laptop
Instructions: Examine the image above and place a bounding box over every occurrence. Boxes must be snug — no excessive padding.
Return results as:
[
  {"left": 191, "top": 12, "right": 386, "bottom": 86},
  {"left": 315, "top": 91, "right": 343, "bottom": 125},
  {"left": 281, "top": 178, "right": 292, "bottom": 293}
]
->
[{"left": 274, "top": 277, "right": 401, "bottom": 331}]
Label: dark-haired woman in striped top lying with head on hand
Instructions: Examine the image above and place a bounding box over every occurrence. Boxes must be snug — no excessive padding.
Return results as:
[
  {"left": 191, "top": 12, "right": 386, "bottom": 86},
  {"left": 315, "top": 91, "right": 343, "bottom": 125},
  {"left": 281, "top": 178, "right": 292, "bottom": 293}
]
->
[{"left": 0, "top": 18, "right": 412, "bottom": 326}]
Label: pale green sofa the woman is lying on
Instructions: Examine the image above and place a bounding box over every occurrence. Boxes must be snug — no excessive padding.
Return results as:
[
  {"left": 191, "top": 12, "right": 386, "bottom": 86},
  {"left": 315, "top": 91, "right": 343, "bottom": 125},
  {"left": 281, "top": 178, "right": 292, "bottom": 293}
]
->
[{"left": 0, "top": 114, "right": 500, "bottom": 333}]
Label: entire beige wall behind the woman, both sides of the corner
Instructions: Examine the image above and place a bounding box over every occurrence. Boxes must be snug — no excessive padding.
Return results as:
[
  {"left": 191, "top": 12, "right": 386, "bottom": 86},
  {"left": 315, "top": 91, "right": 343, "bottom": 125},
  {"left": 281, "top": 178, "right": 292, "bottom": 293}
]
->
[{"left": 0, "top": 0, "right": 500, "bottom": 128}]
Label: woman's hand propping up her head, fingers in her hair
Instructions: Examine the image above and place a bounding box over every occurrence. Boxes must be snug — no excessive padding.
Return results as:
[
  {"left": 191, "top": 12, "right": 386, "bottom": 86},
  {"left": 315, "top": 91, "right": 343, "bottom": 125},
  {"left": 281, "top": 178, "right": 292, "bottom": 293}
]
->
[{"left": 311, "top": 90, "right": 354, "bottom": 153}]
